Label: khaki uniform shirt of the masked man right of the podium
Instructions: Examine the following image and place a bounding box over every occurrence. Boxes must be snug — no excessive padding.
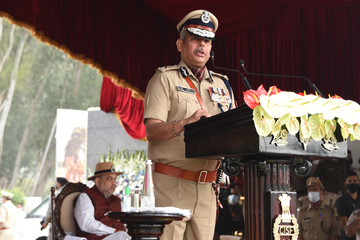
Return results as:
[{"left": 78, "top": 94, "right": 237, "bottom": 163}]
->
[{"left": 297, "top": 203, "right": 340, "bottom": 240}]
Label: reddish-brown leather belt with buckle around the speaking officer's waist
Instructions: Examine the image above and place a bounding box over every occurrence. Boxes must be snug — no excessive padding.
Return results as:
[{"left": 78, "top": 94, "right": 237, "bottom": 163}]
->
[{"left": 154, "top": 162, "right": 217, "bottom": 183}]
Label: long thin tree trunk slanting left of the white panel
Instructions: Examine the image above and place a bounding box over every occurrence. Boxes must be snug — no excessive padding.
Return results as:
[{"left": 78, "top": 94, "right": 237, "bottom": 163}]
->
[{"left": 10, "top": 53, "right": 53, "bottom": 189}]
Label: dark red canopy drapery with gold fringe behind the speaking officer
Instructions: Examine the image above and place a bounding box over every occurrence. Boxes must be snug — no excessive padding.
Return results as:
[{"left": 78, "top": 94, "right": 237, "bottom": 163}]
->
[{"left": 0, "top": 0, "right": 360, "bottom": 140}]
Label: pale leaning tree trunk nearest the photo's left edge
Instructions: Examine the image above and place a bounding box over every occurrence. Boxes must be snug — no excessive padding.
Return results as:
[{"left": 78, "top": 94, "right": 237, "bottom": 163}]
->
[{"left": 0, "top": 30, "right": 29, "bottom": 170}]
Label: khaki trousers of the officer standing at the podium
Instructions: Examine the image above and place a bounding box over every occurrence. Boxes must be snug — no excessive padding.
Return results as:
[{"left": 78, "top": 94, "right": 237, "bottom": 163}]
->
[{"left": 153, "top": 172, "right": 216, "bottom": 240}]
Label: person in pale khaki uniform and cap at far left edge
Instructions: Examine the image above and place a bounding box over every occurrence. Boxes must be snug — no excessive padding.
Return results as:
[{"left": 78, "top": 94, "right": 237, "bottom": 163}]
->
[{"left": 0, "top": 191, "right": 17, "bottom": 240}]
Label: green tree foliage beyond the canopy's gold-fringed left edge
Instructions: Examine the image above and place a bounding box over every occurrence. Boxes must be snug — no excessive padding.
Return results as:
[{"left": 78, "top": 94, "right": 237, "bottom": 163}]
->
[{"left": 0, "top": 19, "right": 102, "bottom": 196}]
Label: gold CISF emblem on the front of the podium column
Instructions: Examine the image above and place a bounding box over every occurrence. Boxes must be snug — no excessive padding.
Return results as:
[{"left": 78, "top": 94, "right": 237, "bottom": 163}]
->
[{"left": 273, "top": 193, "right": 299, "bottom": 240}]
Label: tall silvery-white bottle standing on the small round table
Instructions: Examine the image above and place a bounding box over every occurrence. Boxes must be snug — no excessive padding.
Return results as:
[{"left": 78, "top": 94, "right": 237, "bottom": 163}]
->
[{"left": 141, "top": 160, "right": 155, "bottom": 211}]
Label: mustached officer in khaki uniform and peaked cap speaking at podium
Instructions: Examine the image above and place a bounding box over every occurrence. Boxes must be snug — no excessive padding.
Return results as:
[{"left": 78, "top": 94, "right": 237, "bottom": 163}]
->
[{"left": 144, "top": 10, "right": 234, "bottom": 240}]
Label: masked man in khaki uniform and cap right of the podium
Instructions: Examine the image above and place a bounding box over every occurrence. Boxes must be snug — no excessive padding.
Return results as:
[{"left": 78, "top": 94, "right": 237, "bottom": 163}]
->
[{"left": 297, "top": 177, "right": 340, "bottom": 240}]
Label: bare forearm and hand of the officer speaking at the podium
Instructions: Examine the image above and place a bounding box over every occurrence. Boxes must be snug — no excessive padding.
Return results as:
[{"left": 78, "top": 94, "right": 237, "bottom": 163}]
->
[{"left": 145, "top": 109, "right": 211, "bottom": 142}]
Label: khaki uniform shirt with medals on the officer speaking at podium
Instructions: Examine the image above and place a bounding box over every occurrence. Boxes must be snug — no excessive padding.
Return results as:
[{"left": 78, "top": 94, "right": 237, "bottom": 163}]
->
[{"left": 144, "top": 61, "right": 235, "bottom": 171}]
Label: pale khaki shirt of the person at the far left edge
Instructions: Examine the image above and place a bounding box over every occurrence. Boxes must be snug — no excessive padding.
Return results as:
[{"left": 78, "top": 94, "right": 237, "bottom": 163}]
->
[{"left": 0, "top": 200, "right": 17, "bottom": 240}]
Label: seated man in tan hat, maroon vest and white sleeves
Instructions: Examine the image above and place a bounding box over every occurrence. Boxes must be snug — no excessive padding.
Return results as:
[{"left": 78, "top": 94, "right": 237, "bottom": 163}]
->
[{"left": 74, "top": 162, "right": 130, "bottom": 240}]
